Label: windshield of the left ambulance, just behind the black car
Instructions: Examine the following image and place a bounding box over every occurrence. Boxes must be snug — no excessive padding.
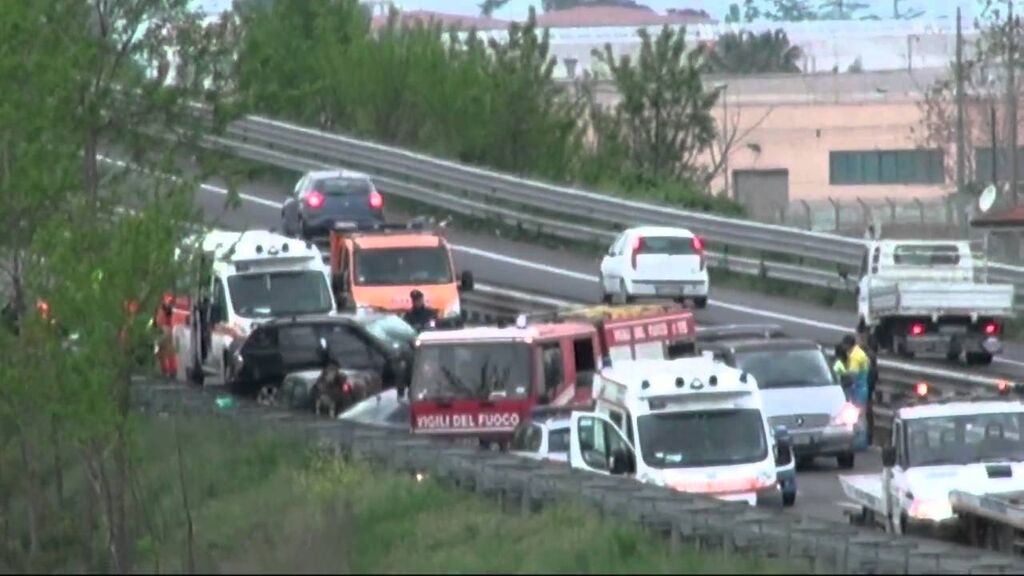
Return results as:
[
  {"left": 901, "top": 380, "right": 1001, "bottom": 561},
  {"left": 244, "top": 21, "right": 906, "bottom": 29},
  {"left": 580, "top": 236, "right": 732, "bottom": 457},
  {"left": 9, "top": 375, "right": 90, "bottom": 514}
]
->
[{"left": 227, "top": 271, "right": 331, "bottom": 318}]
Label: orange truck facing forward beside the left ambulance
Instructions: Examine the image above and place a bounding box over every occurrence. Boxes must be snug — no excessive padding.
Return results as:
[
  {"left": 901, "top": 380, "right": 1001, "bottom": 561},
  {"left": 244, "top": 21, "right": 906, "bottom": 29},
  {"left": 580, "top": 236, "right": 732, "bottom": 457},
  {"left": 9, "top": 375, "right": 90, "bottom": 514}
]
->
[{"left": 331, "top": 221, "right": 473, "bottom": 321}]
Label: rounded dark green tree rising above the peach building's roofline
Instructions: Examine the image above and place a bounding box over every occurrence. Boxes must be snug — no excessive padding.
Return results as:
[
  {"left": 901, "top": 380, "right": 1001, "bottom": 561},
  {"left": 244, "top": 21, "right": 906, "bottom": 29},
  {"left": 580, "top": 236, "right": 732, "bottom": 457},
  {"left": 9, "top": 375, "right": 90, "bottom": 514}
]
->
[{"left": 705, "top": 29, "right": 804, "bottom": 74}]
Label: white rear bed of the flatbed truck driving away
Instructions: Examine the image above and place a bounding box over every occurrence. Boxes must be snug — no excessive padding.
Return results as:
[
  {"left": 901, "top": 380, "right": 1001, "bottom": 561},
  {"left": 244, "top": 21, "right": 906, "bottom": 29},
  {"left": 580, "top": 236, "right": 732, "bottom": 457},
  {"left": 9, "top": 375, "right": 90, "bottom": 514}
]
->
[{"left": 869, "top": 281, "right": 1014, "bottom": 318}]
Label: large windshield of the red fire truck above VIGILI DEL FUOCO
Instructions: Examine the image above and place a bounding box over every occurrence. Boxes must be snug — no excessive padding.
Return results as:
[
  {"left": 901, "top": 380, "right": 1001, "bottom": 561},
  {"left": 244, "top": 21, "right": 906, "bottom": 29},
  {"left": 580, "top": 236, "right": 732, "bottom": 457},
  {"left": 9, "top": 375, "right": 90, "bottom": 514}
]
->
[{"left": 413, "top": 342, "right": 532, "bottom": 400}]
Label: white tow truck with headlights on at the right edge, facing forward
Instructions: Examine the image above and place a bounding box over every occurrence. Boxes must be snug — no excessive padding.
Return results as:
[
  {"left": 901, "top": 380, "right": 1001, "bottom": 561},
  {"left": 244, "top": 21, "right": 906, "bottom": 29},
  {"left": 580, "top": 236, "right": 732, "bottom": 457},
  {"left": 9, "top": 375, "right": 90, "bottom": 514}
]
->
[{"left": 839, "top": 381, "right": 1024, "bottom": 539}]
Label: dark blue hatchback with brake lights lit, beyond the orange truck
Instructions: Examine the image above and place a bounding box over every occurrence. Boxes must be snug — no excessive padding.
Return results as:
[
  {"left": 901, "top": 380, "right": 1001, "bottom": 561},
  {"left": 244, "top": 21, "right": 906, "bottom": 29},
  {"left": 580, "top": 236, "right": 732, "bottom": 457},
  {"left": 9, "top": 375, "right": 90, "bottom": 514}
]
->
[{"left": 281, "top": 170, "right": 384, "bottom": 240}]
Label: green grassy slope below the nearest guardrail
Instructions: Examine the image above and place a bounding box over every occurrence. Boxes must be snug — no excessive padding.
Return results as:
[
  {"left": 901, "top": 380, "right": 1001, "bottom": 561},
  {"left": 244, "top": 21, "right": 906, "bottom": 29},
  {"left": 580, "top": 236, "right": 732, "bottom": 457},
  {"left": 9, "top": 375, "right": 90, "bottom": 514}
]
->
[{"left": 0, "top": 416, "right": 790, "bottom": 574}]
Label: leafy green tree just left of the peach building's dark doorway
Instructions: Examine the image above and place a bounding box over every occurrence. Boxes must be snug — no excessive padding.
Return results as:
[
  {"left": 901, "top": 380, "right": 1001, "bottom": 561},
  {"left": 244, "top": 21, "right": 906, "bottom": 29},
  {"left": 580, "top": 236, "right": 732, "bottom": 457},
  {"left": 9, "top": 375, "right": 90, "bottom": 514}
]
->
[{"left": 591, "top": 26, "right": 719, "bottom": 182}]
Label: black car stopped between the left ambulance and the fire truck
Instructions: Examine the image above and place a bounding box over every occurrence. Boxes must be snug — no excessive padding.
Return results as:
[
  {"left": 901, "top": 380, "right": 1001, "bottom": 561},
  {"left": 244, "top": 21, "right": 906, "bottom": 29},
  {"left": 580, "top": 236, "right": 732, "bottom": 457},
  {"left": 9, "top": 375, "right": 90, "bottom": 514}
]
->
[{"left": 229, "top": 315, "right": 416, "bottom": 395}]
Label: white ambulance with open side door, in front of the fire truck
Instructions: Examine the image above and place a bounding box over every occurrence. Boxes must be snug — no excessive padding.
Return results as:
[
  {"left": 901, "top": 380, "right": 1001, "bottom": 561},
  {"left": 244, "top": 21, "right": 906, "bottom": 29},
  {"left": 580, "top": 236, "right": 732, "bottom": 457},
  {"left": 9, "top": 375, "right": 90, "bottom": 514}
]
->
[{"left": 569, "top": 355, "right": 796, "bottom": 505}]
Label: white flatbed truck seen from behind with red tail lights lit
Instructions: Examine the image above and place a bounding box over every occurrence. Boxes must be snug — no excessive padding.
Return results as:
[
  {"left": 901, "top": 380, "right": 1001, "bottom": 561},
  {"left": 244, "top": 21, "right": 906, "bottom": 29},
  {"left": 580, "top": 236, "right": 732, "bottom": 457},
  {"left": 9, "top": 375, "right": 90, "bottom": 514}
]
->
[{"left": 857, "top": 240, "right": 1014, "bottom": 365}]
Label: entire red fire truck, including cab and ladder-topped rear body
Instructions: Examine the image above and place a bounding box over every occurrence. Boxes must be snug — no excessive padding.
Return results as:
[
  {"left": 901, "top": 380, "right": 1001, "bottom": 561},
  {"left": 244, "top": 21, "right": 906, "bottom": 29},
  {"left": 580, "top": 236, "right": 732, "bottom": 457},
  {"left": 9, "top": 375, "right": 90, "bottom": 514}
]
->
[{"left": 410, "top": 305, "right": 695, "bottom": 445}]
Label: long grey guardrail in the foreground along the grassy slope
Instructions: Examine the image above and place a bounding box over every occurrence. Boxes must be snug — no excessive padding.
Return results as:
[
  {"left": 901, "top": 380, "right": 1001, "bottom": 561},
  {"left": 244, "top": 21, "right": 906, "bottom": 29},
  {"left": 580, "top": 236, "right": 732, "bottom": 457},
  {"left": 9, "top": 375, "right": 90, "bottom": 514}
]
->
[{"left": 132, "top": 382, "right": 1024, "bottom": 574}]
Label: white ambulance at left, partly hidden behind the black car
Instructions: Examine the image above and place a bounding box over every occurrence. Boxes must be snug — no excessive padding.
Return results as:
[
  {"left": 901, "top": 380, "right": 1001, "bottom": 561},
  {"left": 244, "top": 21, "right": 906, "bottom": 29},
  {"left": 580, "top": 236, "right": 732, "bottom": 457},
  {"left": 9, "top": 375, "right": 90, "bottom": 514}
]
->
[{"left": 173, "top": 231, "right": 337, "bottom": 384}]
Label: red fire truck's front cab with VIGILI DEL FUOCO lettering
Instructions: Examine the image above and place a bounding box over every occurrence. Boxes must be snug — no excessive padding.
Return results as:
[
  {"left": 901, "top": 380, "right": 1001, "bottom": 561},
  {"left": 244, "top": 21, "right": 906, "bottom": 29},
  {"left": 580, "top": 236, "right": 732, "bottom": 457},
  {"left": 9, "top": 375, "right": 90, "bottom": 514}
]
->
[{"left": 410, "top": 322, "right": 600, "bottom": 445}]
